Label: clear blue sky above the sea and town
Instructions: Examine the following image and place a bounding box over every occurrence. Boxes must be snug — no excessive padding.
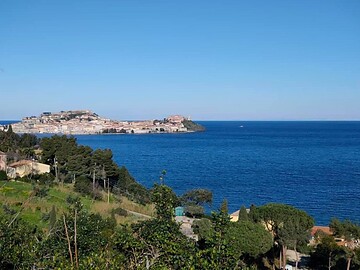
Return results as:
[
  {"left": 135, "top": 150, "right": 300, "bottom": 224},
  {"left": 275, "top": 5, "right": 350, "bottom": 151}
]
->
[{"left": 0, "top": 0, "right": 360, "bottom": 120}]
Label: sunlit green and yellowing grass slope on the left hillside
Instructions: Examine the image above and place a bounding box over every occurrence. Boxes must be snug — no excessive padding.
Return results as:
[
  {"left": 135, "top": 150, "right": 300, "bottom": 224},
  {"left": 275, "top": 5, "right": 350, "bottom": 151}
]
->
[{"left": 0, "top": 181, "right": 154, "bottom": 230}]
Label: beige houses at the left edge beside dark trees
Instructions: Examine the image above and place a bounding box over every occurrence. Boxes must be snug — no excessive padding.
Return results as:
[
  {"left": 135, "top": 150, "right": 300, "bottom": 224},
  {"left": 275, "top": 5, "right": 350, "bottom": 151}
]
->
[{"left": 0, "top": 151, "right": 50, "bottom": 179}]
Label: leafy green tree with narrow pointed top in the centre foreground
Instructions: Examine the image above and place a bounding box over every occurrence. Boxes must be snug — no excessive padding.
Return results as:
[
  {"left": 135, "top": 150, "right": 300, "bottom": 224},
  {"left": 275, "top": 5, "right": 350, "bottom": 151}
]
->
[{"left": 133, "top": 184, "right": 194, "bottom": 269}]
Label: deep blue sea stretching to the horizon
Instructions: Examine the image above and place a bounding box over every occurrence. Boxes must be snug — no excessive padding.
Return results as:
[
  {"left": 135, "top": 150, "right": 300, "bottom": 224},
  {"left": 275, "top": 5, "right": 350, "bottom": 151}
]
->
[{"left": 1, "top": 121, "right": 360, "bottom": 225}]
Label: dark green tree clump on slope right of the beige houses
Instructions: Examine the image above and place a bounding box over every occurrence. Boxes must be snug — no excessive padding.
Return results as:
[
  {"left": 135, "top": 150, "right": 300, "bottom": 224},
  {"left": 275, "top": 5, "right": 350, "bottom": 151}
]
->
[{"left": 40, "top": 135, "right": 150, "bottom": 204}]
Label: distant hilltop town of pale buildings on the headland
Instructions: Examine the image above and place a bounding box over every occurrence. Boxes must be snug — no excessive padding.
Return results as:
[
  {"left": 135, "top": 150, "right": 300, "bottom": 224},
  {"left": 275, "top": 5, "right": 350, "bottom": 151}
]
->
[{"left": 0, "top": 110, "right": 204, "bottom": 134}]
